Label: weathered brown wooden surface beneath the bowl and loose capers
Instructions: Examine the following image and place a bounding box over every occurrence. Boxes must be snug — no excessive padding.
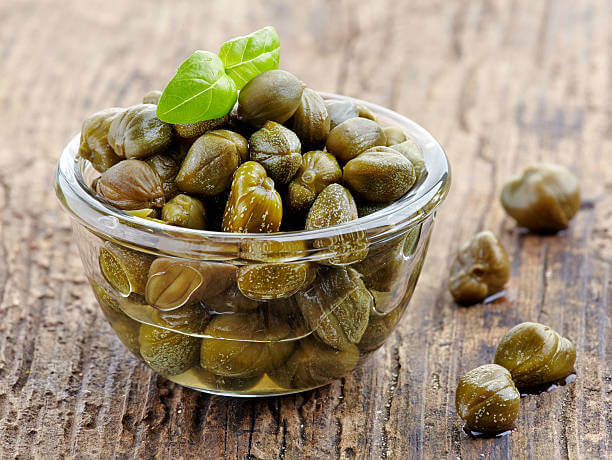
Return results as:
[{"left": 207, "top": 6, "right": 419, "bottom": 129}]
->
[{"left": 0, "top": 0, "right": 612, "bottom": 459}]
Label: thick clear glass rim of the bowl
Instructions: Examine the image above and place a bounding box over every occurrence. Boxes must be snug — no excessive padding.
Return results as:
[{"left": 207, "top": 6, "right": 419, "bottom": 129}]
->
[{"left": 54, "top": 92, "right": 451, "bottom": 259}]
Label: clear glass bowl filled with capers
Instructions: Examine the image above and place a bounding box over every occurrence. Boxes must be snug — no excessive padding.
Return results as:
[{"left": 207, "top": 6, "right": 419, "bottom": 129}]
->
[{"left": 55, "top": 94, "right": 450, "bottom": 396}]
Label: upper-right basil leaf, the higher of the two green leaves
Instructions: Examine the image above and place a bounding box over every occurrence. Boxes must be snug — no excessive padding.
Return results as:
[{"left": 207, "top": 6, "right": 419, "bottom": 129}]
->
[{"left": 219, "top": 26, "right": 280, "bottom": 89}]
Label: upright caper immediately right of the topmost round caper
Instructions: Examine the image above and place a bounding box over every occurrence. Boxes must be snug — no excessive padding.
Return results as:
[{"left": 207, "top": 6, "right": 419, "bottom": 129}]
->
[{"left": 291, "top": 88, "right": 330, "bottom": 147}]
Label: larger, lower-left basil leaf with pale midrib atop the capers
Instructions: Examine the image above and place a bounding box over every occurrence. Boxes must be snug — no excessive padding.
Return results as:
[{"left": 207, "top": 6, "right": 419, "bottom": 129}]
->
[{"left": 157, "top": 51, "right": 237, "bottom": 124}]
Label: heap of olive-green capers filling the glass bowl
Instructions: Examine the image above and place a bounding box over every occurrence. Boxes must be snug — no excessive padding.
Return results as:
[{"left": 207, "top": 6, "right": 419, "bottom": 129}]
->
[{"left": 79, "top": 70, "right": 427, "bottom": 391}]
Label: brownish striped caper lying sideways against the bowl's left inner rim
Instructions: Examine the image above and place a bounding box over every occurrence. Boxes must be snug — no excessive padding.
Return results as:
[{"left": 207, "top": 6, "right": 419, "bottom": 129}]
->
[{"left": 95, "top": 160, "right": 164, "bottom": 209}]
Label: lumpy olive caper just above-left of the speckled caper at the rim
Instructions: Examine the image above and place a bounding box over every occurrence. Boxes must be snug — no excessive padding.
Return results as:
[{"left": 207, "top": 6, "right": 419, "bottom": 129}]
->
[{"left": 287, "top": 150, "right": 342, "bottom": 213}]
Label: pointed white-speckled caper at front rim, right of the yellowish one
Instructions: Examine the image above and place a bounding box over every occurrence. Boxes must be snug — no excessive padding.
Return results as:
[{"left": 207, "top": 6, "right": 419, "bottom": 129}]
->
[{"left": 306, "top": 184, "right": 368, "bottom": 265}]
